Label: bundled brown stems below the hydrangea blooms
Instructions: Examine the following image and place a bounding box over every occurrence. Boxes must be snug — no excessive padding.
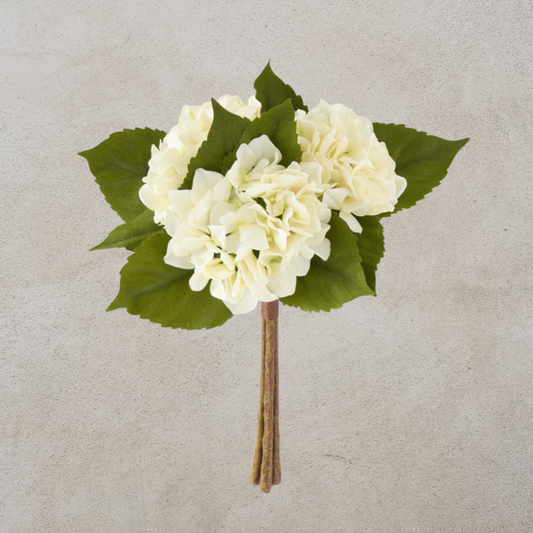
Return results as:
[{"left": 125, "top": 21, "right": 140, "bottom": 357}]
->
[{"left": 250, "top": 300, "right": 281, "bottom": 492}]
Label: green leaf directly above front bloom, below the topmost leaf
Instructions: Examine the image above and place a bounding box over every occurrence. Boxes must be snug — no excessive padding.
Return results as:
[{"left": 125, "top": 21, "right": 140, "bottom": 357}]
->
[{"left": 222, "top": 100, "right": 302, "bottom": 174}]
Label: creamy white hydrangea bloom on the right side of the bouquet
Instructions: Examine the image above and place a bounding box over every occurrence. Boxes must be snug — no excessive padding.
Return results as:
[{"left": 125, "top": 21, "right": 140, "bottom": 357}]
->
[{"left": 296, "top": 100, "right": 407, "bottom": 233}]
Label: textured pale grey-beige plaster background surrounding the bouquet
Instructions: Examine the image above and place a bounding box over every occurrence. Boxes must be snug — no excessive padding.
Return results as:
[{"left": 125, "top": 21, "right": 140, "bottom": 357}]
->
[{"left": 0, "top": 0, "right": 533, "bottom": 533}]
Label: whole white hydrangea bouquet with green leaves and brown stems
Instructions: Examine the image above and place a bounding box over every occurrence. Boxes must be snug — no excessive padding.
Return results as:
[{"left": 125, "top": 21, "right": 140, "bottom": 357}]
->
[{"left": 80, "top": 65, "right": 468, "bottom": 492}]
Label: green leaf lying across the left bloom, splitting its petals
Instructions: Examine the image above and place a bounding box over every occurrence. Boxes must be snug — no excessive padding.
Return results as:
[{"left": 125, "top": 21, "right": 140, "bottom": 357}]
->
[{"left": 180, "top": 99, "right": 250, "bottom": 189}]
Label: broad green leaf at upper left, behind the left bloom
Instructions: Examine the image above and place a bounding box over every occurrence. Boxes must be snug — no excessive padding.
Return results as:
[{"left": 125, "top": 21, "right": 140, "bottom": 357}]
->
[{"left": 79, "top": 128, "right": 166, "bottom": 222}]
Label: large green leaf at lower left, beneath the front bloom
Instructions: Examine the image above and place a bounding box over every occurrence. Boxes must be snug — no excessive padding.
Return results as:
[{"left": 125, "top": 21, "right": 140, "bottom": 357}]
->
[{"left": 107, "top": 233, "right": 233, "bottom": 329}]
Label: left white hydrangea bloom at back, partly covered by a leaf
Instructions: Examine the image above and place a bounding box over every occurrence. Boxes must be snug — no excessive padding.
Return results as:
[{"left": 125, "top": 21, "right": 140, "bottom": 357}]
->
[{"left": 139, "top": 94, "right": 261, "bottom": 223}]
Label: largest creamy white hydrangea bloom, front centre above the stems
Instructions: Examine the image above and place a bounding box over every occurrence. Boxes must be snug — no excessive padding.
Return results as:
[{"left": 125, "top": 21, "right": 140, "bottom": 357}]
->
[{"left": 165, "top": 135, "right": 331, "bottom": 314}]
